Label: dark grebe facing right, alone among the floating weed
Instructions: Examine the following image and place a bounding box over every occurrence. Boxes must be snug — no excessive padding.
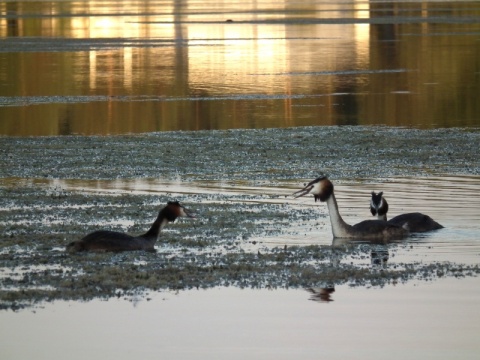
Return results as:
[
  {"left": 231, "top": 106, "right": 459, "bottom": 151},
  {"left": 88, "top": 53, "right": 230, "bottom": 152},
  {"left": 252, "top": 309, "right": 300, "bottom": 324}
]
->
[{"left": 67, "top": 201, "right": 193, "bottom": 252}]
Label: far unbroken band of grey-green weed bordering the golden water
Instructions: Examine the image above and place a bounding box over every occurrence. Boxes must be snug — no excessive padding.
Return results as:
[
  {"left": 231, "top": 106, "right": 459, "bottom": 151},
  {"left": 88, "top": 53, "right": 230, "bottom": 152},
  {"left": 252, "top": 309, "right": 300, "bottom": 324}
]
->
[{"left": 0, "top": 127, "right": 480, "bottom": 181}]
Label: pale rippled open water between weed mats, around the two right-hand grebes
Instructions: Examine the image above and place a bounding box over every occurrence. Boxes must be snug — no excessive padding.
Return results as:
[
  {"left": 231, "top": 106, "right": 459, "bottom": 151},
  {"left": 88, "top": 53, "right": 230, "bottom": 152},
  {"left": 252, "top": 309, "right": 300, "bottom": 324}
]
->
[{"left": 40, "top": 176, "right": 480, "bottom": 264}]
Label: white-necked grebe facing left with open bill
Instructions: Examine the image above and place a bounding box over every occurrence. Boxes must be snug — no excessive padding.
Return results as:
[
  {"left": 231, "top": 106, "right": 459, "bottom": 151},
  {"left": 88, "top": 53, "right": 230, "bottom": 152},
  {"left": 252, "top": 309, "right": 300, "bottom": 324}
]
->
[{"left": 293, "top": 176, "right": 408, "bottom": 240}]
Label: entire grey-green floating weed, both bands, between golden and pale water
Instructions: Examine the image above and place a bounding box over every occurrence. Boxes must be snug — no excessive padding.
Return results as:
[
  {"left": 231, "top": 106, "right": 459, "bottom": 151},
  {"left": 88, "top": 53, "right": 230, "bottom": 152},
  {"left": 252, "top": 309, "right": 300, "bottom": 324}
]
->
[{"left": 0, "top": 127, "right": 480, "bottom": 310}]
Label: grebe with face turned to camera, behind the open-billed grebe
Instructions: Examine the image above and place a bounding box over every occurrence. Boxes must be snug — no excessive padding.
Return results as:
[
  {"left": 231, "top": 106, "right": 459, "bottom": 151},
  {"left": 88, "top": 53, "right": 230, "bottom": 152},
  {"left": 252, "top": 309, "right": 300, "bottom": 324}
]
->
[{"left": 370, "top": 191, "right": 443, "bottom": 233}]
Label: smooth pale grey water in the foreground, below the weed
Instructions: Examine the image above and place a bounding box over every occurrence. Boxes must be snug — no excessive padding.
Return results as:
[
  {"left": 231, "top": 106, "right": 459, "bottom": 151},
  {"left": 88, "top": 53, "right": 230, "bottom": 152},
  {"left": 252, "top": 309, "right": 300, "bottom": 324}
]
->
[{"left": 0, "top": 278, "right": 480, "bottom": 360}]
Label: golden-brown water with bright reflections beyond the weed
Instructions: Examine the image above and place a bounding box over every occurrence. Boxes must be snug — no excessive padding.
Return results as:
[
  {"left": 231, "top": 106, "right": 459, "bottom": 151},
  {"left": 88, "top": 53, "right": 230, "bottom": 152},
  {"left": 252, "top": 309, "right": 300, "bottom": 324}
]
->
[{"left": 0, "top": 0, "right": 480, "bottom": 136}]
